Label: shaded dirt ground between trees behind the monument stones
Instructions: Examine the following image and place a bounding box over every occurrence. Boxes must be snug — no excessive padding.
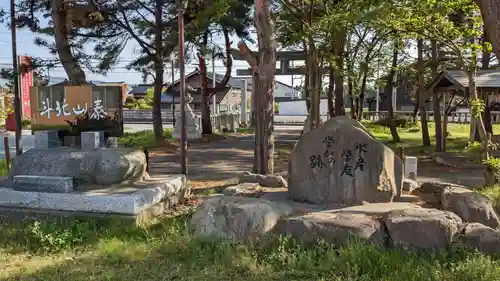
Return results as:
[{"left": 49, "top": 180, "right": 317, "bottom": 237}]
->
[{"left": 150, "top": 131, "right": 484, "bottom": 187}]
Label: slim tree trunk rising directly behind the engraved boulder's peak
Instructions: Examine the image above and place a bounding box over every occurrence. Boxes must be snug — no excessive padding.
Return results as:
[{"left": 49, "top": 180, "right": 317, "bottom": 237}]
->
[{"left": 335, "top": 32, "right": 347, "bottom": 116}]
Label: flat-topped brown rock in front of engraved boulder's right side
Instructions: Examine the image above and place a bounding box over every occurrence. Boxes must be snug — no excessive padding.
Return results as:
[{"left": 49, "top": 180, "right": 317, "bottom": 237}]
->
[{"left": 384, "top": 208, "right": 462, "bottom": 250}]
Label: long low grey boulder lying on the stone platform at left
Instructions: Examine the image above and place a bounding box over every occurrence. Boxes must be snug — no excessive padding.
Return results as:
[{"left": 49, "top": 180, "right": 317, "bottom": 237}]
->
[{"left": 9, "top": 147, "right": 147, "bottom": 185}]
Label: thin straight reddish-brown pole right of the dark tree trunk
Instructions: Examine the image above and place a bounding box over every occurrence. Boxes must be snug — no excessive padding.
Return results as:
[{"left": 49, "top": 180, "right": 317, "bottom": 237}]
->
[{"left": 178, "top": 0, "right": 187, "bottom": 176}]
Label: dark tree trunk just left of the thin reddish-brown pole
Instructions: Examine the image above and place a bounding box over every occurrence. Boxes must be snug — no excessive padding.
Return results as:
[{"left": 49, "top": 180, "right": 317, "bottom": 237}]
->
[{"left": 153, "top": 0, "right": 164, "bottom": 142}]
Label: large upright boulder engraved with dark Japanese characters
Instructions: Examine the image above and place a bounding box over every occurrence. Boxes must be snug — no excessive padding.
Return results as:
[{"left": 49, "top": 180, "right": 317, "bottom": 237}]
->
[{"left": 288, "top": 117, "right": 403, "bottom": 205}]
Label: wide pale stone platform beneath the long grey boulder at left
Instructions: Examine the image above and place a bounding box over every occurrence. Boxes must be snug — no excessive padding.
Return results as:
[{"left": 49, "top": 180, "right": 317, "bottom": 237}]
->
[{"left": 0, "top": 175, "right": 189, "bottom": 215}]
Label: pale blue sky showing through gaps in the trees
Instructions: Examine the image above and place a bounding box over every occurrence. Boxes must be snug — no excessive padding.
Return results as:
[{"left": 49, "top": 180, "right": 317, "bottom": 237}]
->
[{"left": 0, "top": 0, "right": 299, "bottom": 84}]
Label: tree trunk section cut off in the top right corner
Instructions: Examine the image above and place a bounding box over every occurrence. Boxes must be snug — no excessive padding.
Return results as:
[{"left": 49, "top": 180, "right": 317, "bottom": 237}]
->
[{"left": 475, "top": 0, "right": 500, "bottom": 58}]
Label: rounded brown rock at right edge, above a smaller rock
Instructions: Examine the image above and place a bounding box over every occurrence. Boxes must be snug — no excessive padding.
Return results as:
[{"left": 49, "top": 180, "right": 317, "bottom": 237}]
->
[{"left": 441, "top": 187, "right": 500, "bottom": 229}]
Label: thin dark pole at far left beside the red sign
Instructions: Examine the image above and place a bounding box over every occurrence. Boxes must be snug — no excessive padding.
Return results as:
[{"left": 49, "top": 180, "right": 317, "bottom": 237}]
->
[{"left": 10, "top": 0, "right": 23, "bottom": 156}]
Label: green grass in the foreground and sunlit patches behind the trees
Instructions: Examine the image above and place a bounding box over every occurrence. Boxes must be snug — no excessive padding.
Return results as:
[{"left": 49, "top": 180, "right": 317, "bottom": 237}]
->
[{"left": 0, "top": 123, "right": 500, "bottom": 281}]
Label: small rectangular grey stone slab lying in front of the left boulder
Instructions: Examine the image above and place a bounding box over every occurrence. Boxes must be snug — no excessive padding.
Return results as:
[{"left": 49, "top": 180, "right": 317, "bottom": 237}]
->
[{"left": 12, "top": 175, "right": 73, "bottom": 193}]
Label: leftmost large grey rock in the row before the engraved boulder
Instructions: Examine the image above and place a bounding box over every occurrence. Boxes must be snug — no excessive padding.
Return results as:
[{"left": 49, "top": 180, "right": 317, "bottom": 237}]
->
[{"left": 190, "top": 195, "right": 293, "bottom": 240}]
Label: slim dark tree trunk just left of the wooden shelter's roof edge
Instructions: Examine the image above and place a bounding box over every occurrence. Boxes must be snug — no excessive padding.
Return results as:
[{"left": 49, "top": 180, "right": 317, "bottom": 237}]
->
[{"left": 417, "top": 38, "right": 431, "bottom": 146}]
